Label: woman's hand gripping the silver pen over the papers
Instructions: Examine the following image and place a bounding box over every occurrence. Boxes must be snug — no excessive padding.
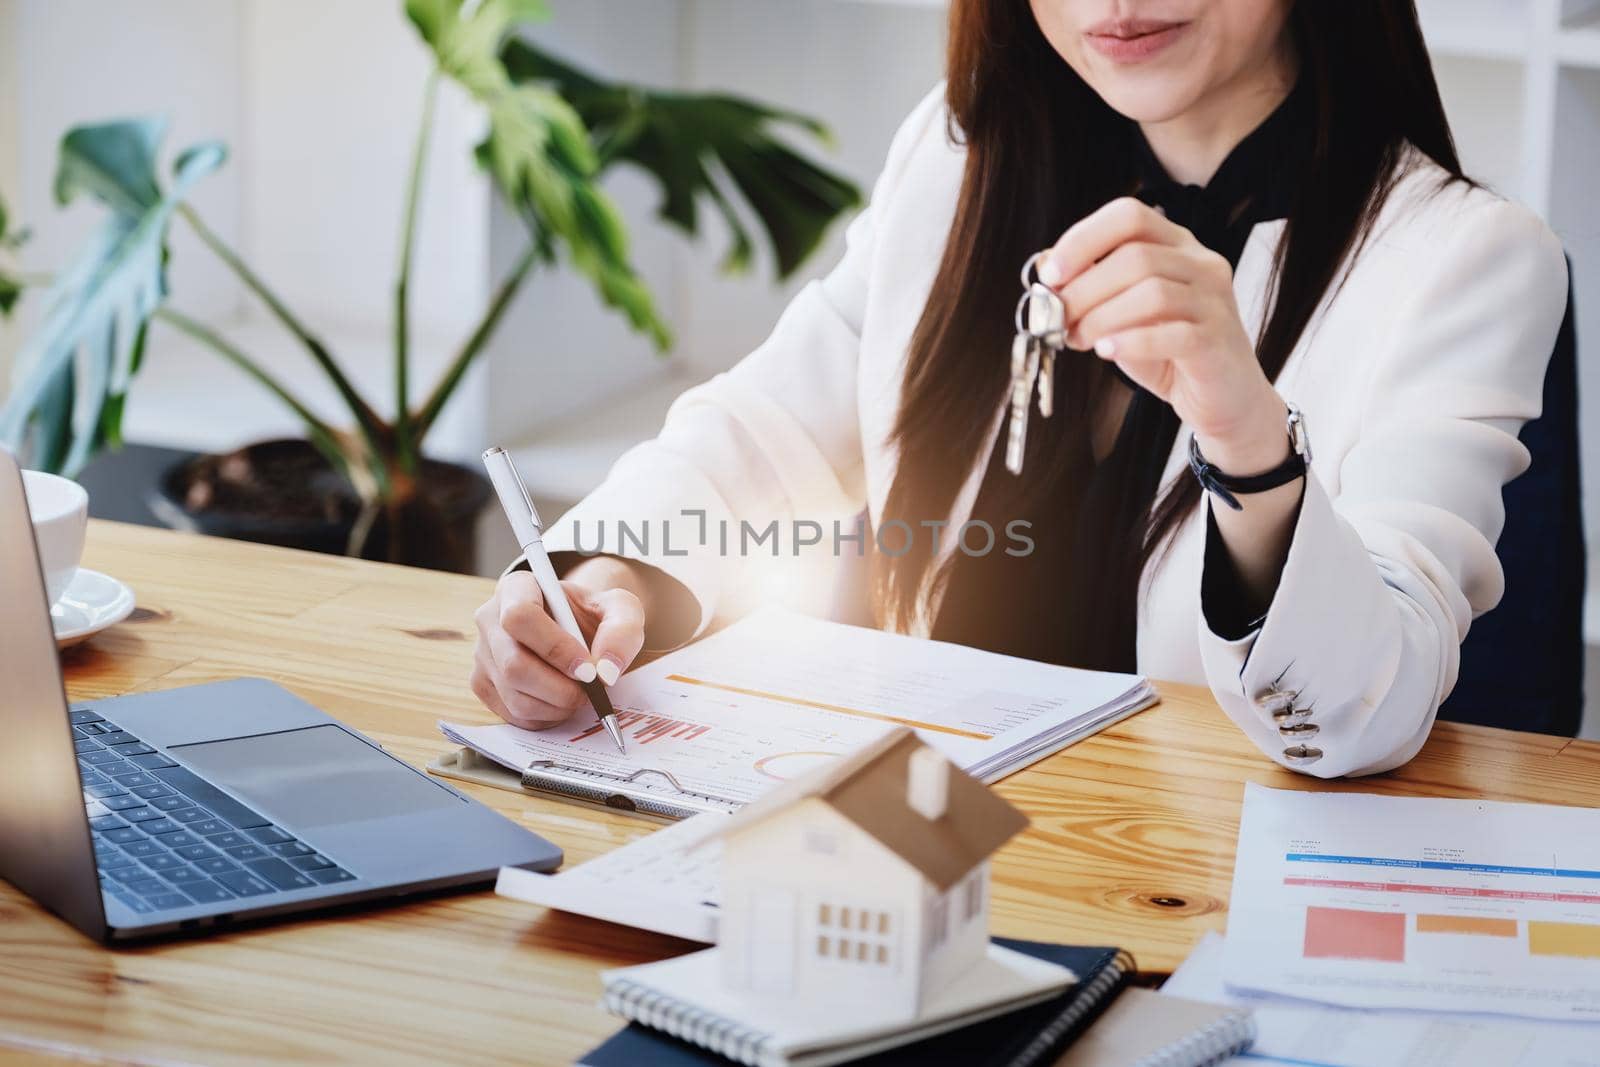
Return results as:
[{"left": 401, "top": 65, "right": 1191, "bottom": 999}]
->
[{"left": 472, "top": 557, "right": 645, "bottom": 729}]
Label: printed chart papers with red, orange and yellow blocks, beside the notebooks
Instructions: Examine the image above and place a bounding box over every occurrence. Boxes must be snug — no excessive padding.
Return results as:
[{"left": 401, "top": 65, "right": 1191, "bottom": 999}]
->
[{"left": 1163, "top": 784, "right": 1600, "bottom": 1067}]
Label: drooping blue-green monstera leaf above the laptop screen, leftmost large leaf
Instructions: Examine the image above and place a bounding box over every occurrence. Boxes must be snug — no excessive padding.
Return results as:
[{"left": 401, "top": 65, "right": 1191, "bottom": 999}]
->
[{"left": 0, "top": 118, "right": 226, "bottom": 474}]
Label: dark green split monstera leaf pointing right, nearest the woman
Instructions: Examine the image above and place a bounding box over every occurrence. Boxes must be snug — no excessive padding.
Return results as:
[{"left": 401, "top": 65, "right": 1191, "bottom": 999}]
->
[{"left": 501, "top": 38, "right": 861, "bottom": 278}]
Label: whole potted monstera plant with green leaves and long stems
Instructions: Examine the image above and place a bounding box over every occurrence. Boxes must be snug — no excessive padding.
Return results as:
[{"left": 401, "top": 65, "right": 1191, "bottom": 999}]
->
[{"left": 0, "top": 0, "right": 861, "bottom": 565}]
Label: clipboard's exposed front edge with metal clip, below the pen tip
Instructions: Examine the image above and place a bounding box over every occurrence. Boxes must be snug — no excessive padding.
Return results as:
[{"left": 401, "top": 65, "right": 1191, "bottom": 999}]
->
[{"left": 427, "top": 747, "right": 742, "bottom": 822}]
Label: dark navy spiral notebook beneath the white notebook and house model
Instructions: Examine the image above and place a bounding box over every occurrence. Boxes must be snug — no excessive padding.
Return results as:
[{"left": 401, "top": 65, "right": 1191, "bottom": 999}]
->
[{"left": 582, "top": 937, "right": 1139, "bottom": 1067}]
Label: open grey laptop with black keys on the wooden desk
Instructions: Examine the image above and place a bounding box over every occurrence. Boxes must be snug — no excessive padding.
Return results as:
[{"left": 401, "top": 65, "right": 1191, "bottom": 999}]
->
[{"left": 0, "top": 450, "right": 562, "bottom": 942}]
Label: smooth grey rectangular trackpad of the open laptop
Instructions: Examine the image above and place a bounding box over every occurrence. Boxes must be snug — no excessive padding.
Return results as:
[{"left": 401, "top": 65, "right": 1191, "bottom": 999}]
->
[{"left": 170, "top": 726, "right": 461, "bottom": 830}]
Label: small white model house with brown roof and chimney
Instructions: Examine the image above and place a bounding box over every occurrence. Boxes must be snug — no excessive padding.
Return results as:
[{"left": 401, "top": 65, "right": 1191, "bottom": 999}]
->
[{"left": 707, "top": 728, "right": 1027, "bottom": 1019}]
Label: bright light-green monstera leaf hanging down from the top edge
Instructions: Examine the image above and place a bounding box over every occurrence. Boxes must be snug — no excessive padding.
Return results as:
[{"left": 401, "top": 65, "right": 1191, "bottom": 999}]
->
[{"left": 406, "top": 0, "right": 670, "bottom": 347}]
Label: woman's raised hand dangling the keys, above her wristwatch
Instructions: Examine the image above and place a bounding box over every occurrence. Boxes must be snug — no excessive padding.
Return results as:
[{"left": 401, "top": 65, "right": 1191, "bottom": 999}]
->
[{"left": 1038, "top": 197, "right": 1288, "bottom": 475}]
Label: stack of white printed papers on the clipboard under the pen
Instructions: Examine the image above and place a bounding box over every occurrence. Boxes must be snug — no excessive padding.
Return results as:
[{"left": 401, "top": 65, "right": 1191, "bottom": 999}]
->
[{"left": 440, "top": 609, "right": 1155, "bottom": 817}]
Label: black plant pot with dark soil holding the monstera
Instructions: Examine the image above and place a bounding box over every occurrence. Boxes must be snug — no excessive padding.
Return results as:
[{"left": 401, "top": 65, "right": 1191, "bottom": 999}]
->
[{"left": 149, "top": 440, "right": 491, "bottom": 574}]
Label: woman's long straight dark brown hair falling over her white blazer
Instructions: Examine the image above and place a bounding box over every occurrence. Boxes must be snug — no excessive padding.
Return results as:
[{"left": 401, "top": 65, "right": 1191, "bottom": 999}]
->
[{"left": 874, "top": 0, "right": 1462, "bottom": 643}]
